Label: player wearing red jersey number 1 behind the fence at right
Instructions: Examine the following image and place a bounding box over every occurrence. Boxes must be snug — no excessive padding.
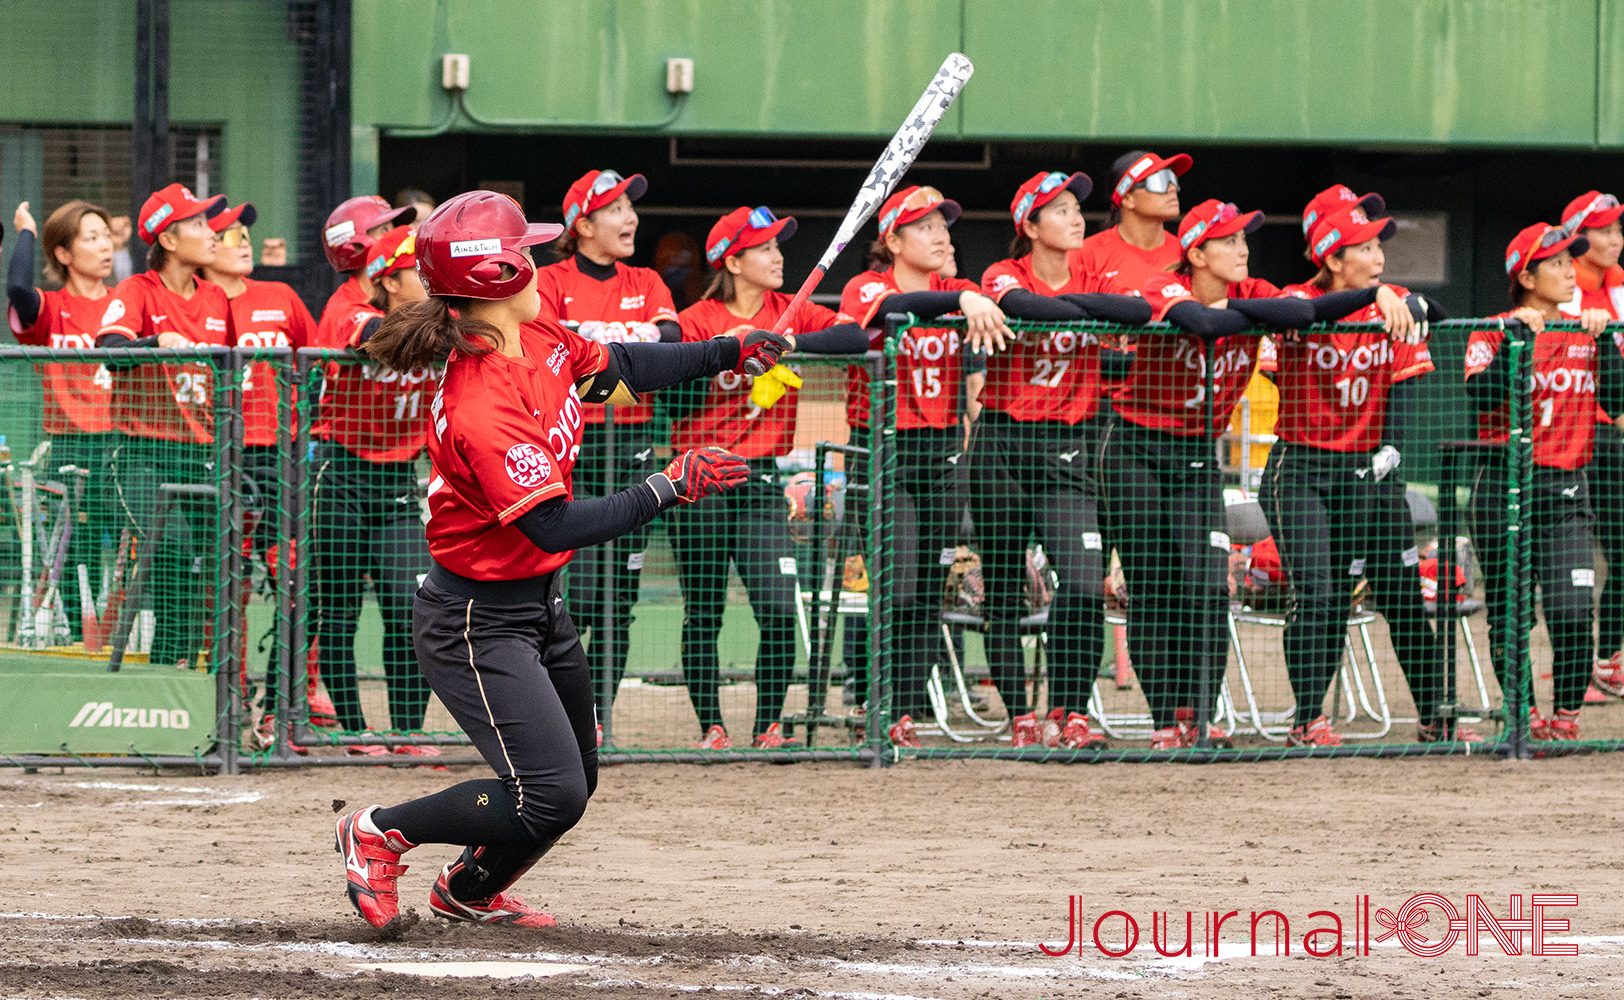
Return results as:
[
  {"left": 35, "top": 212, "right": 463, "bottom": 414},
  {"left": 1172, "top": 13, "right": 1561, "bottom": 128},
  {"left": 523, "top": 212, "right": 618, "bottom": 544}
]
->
[{"left": 1466, "top": 222, "right": 1624, "bottom": 740}]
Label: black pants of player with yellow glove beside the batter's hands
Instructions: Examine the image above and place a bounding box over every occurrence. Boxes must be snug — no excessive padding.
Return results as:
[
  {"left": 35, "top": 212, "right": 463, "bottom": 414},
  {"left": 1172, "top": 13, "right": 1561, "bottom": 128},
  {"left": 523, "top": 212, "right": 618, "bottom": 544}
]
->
[{"left": 666, "top": 459, "right": 796, "bottom": 734}]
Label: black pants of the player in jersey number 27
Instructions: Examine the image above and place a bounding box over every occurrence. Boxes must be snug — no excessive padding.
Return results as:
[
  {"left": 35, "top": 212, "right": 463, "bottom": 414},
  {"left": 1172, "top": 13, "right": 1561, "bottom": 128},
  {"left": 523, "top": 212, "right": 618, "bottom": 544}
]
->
[{"left": 970, "top": 411, "right": 1104, "bottom": 716}]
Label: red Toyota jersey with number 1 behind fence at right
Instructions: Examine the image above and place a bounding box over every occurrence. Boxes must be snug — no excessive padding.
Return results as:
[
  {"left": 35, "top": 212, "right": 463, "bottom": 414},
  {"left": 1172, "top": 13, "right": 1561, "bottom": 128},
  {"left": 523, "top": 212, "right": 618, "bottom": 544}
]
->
[{"left": 1466, "top": 312, "right": 1596, "bottom": 469}]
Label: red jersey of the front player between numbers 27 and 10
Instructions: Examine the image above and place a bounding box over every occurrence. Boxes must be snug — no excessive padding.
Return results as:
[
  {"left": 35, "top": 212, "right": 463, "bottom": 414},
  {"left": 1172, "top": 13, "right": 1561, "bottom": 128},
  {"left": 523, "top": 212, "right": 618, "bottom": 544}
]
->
[{"left": 1114, "top": 274, "right": 1285, "bottom": 437}]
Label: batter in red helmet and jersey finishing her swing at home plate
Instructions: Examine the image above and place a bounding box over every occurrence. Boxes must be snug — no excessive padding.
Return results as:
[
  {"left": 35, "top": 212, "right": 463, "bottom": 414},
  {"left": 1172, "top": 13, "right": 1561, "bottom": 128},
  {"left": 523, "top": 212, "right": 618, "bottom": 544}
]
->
[{"left": 336, "top": 192, "right": 788, "bottom": 927}]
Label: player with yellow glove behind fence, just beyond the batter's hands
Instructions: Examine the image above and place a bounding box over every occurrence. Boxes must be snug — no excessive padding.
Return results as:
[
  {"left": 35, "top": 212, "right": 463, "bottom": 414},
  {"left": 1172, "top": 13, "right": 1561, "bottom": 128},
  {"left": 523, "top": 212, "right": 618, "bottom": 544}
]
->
[{"left": 666, "top": 206, "right": 869, "bottom": 748}]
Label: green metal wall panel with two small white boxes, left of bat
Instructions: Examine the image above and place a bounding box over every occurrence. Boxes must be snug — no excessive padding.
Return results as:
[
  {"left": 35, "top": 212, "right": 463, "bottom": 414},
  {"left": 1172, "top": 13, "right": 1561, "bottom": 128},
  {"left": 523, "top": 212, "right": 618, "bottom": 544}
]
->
[{"left": 354, "top": 0, "right": 960, "bottom": 135}]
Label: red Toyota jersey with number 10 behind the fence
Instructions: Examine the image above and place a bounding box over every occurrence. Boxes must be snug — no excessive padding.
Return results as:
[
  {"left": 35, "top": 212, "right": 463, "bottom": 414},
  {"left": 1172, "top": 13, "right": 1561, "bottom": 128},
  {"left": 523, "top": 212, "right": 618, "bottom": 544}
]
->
[{"left": 1257, "top": 282, "right": 1432, "bottom": 451}]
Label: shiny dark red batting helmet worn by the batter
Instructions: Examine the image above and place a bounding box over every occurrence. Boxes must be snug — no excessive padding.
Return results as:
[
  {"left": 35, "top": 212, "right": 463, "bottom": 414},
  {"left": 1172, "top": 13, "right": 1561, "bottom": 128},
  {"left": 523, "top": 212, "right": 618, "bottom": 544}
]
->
[{"left": 417, "top": 192, "right": 564, "bottom": 299}]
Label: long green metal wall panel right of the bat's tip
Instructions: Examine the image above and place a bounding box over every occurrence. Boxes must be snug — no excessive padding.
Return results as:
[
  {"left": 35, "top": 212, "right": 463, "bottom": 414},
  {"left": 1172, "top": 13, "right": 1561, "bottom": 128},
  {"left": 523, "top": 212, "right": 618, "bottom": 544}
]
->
[{"left": 965, "top": 0, "right": 1616, "bottom": 146}]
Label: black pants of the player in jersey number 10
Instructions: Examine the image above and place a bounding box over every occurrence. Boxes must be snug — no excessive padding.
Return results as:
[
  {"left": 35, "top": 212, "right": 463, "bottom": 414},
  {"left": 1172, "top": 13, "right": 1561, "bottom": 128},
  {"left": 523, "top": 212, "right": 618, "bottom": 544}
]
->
[{"left": 1259, "top": 442, "right": 1444, "bottom": 726}]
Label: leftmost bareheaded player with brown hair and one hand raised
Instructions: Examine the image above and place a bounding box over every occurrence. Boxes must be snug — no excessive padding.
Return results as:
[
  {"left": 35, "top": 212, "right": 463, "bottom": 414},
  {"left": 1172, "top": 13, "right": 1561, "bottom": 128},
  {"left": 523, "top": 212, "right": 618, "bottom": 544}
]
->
[{"left": 6, "top": 201, "right": 120, "bottom": 640}]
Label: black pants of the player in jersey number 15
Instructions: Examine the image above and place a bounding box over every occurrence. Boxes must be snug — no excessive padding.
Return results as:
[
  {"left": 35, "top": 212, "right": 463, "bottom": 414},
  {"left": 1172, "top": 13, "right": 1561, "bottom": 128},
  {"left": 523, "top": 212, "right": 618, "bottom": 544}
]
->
[{"left": 836, "top": 427, "right": 965, "bottom": 718}]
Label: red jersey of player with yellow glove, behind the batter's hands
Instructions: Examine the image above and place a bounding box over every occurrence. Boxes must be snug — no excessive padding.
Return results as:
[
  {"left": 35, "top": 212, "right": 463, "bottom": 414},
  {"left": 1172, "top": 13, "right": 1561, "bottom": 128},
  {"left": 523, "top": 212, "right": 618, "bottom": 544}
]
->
[{"left": 671, "top": 291, "right": 851, "bottom": 458}]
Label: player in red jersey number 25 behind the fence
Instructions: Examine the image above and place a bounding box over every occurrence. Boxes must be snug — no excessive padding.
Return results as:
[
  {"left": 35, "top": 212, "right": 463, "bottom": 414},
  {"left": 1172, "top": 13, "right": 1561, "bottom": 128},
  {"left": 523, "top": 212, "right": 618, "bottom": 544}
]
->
[{"left": 96, "top": 183, "right": 234, "bottom": 664}]
